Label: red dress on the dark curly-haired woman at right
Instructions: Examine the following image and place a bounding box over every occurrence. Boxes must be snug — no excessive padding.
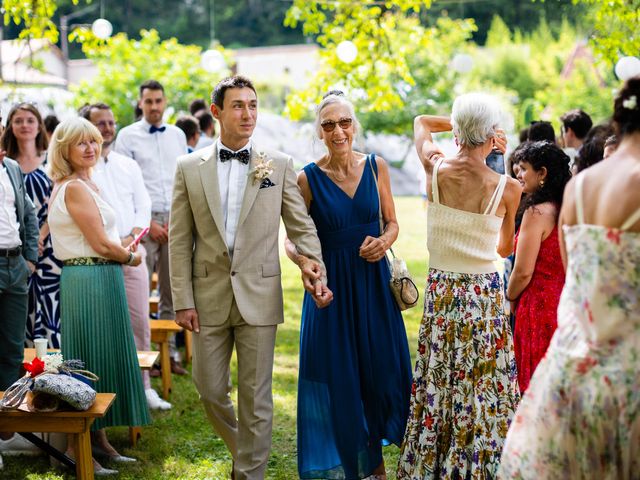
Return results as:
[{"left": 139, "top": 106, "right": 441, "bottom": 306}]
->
[{"left": 513, "top": 226, "right": 564, "bottom": 392}]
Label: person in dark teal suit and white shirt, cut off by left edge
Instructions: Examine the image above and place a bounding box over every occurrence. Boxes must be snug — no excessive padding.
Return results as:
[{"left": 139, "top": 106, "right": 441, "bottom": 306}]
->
[{"left": 0, "top": 147, "right": 39, "bottom": 462}]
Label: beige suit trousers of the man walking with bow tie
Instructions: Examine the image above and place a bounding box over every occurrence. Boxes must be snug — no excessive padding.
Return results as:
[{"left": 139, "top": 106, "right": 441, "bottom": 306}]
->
[{"left": 193, "top": 299, "right": 277, "bottom": 480}]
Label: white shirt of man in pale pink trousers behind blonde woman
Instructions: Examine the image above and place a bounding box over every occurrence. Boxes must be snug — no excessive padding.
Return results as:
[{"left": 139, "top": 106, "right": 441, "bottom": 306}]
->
[{"left": 92, "top": 152, "right": 151, "bottom": 237}]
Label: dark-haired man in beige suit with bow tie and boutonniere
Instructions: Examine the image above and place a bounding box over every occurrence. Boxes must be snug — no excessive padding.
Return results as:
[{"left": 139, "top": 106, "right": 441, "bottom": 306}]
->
[{"left": 169, "top": 76, "right": 332, "bottom": 480}]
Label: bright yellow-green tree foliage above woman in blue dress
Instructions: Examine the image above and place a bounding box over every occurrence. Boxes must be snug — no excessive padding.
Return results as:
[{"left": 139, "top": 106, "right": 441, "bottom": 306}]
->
[{"left": 285, "top": 0, "right": 473, "bottom": 131}]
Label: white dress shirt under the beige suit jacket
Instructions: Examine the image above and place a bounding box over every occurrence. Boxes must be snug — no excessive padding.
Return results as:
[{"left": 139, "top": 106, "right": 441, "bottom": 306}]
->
[{"left": 216, "top": 138, "right": 251, "bottom": 255}]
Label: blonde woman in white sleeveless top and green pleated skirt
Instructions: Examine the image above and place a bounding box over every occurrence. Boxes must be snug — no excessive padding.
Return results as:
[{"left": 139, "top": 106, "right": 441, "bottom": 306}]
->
[{"left": 49, "top": 118, "right": 150, "bottom": 474}]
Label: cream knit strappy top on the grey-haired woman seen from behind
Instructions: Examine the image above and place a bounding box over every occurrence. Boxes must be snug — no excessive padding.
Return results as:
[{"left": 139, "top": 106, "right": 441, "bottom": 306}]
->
[{"left": 427, "top": 158, "right": 507, "bottom": 273}]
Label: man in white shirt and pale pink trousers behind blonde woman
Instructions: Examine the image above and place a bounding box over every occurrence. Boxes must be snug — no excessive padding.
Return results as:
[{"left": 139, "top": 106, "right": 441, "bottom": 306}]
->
[{"left": 81, "top": 103, "right": 171, "bottom": 410}]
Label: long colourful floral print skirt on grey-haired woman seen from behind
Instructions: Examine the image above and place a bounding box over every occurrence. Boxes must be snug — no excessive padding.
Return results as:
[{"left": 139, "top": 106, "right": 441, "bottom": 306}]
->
[{"left": 398, "top": 269, "right": 520, "bottom": 480}]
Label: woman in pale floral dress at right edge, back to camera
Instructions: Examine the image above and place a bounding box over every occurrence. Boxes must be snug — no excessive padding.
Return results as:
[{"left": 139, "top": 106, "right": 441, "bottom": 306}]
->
[{"left": 499, "top": 76, "right": 640, "bottom": 480}]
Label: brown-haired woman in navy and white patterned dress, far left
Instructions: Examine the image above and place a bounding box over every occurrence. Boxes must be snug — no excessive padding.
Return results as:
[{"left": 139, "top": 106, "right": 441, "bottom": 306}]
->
[{"left": 0, "top": 103, "right": 62, "bottom": 348}]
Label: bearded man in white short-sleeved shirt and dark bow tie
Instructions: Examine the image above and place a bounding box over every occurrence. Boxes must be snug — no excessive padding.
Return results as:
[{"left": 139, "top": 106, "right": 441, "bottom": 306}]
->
[{"left": 114, "top": 80, "right": 187, "bottom": 375}]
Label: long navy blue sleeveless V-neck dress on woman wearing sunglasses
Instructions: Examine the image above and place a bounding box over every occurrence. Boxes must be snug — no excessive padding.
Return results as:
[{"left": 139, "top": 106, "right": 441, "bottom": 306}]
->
[{"left": 298, "top": 156, "right": 411, "bottom": 480}]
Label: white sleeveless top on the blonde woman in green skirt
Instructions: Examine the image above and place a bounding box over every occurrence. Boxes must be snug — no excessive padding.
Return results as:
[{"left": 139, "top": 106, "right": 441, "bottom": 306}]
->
[{"left": 48, "top": 180, "right": 120, "bottom": 260}]
